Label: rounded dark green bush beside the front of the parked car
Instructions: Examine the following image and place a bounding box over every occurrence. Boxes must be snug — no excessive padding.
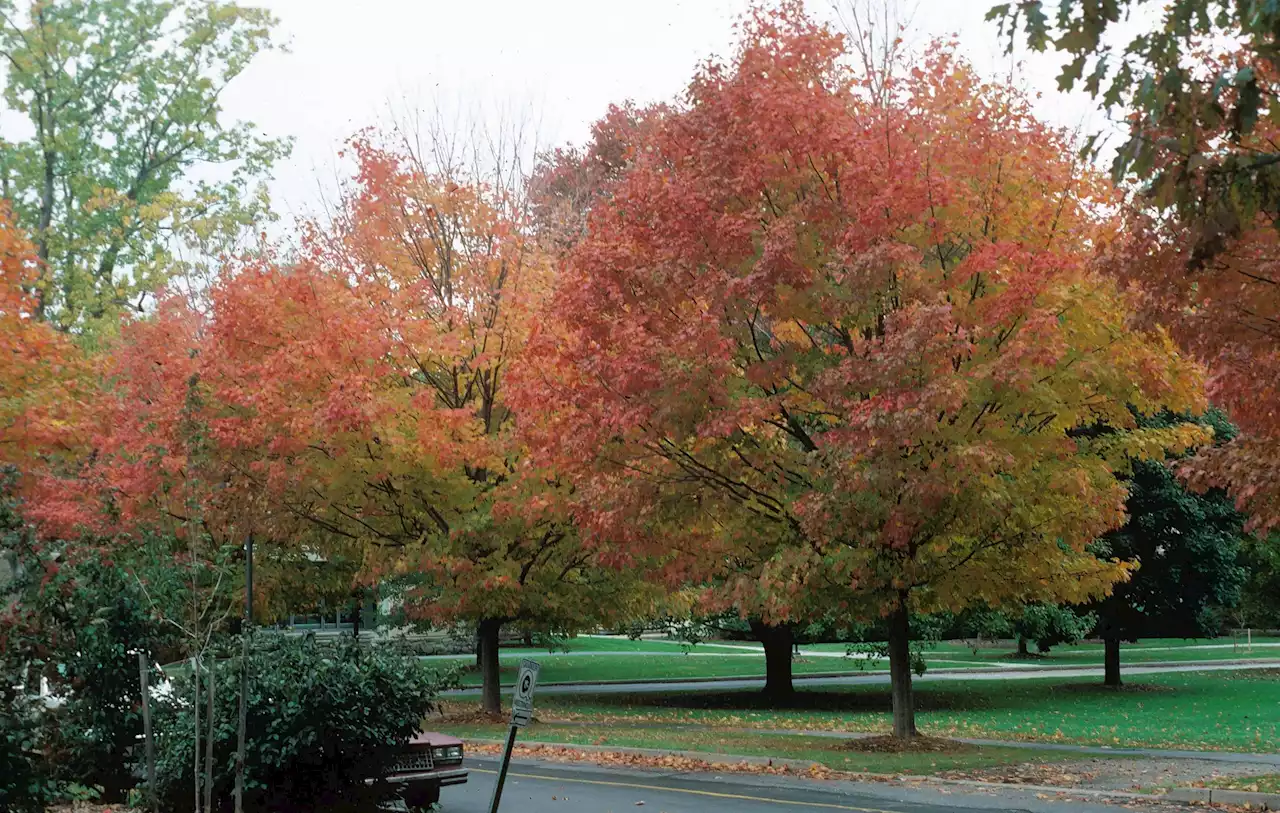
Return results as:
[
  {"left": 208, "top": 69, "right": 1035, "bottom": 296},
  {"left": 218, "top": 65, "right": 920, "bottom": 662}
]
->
[{"left": 155, "top": 636, "right": 453, "bottom": 810}]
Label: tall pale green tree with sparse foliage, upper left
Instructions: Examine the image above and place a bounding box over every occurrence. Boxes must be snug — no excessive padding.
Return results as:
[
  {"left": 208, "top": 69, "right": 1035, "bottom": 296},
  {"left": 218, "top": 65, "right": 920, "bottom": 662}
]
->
[{"left": 0, "top": 0, "right": 288, "bottom": 333}]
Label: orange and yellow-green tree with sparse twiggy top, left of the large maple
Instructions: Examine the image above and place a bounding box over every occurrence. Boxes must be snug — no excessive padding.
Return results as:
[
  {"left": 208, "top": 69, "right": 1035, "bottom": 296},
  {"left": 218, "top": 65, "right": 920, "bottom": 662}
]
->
[{"left": 302, "top": 138, "right": 650, "bottom": 711}]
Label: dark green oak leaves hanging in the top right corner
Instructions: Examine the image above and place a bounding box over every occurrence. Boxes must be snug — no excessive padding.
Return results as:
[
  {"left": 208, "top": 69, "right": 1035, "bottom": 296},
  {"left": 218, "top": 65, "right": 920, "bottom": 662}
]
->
[{"left": 987, "top": 0, "right": 1280, "bottom": 231}]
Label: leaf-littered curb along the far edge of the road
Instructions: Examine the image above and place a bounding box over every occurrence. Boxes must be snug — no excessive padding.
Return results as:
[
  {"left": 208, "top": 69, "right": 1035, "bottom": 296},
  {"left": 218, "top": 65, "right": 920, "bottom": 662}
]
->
[{"left": 465, "top": 739, "right": 1162, "bottom": 801}]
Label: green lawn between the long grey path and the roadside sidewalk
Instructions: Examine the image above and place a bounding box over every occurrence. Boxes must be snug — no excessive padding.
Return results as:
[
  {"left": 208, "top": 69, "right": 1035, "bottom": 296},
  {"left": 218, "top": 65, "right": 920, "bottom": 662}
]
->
[{"left": 501, "top": 670, "right": 1280, "bottom": 752}]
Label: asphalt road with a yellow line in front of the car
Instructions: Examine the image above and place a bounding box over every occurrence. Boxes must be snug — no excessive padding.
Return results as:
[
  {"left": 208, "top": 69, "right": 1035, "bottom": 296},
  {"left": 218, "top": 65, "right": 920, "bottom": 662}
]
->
[{"left": 440, "top": 759, "right": 1172, "bottom": 813}]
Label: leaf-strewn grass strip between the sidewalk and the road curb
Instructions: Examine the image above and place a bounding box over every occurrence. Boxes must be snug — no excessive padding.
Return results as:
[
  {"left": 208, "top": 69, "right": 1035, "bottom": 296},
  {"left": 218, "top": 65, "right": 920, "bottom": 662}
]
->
[{"left": 430, "top": 721, "right": 1105, "bottom": 775}]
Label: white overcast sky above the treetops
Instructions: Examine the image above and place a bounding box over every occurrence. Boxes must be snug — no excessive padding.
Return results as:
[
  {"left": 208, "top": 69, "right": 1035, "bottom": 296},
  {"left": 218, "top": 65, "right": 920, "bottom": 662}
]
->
[{"left": 225, "top": 0, "right": 1121, "bottom": 220}]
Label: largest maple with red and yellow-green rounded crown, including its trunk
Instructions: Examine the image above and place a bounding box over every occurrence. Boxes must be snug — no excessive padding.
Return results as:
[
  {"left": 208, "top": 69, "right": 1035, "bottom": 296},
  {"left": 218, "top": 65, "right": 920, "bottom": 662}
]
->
[{"left": 515, "top": 3, "right": 1202, "bottom": 737}]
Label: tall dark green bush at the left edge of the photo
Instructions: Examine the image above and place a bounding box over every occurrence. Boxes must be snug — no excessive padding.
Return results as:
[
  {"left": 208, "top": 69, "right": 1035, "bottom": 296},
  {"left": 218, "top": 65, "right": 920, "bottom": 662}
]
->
[{"left": 0, "top": 469, "right": 186, "bottom": 809}]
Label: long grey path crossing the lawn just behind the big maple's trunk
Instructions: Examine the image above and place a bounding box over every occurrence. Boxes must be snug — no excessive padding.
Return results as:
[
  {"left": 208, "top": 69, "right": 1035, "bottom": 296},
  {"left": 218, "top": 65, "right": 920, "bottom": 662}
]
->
[{"left": 448, "top": 661, "right": 1276, "bottom": 694}]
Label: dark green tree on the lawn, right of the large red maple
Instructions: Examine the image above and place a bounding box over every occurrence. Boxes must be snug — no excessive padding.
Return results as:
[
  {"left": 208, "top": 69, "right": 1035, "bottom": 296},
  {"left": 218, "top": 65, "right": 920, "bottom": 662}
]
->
[{"left": 1094, "top": 410, "right": 1245, "bottom": 686}]
